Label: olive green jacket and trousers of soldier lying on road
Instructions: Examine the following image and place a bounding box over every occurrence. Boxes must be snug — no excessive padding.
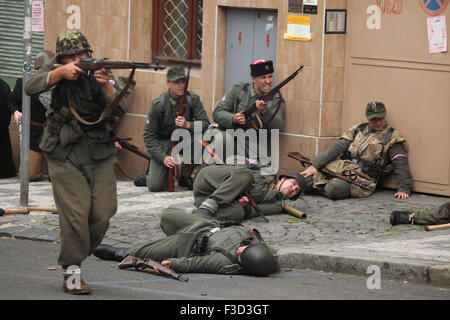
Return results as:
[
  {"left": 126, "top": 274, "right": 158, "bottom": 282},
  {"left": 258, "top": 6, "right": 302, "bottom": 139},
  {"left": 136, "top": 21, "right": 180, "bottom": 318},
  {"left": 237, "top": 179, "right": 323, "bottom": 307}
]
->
[{"left": 129, "top": 208, "right": 276, "bottom": 274}]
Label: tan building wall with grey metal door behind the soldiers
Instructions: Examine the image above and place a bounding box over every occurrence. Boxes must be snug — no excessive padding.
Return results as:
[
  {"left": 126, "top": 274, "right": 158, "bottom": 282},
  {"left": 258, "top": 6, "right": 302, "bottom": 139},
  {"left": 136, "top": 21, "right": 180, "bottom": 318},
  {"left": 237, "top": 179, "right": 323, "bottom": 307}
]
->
[{"left": 7, "top": 0, "right": 450, "bottom": 196}]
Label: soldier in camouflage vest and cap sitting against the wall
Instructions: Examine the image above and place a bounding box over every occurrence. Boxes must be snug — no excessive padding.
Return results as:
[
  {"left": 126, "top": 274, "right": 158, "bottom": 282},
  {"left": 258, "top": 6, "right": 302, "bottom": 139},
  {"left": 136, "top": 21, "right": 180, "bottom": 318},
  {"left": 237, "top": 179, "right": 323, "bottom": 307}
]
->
[{"left": 302, "top": 102, "right": 413, "bottom": 200}]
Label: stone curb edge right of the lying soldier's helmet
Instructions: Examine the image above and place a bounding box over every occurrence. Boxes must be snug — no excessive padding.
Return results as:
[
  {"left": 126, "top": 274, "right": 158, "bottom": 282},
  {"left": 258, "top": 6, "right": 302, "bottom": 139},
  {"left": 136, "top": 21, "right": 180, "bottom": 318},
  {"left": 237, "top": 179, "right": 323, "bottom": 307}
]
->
[{"left": 278, "top": 248, "right": 450, "bottom": 287}]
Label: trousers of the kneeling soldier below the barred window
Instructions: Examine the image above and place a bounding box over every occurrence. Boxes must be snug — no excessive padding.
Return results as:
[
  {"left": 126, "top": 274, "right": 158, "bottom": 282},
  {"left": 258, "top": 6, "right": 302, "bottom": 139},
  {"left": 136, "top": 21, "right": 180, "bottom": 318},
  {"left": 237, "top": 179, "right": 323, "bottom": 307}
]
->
[{"left": 146, "top": 140, "right": 197, "bottom": 192}]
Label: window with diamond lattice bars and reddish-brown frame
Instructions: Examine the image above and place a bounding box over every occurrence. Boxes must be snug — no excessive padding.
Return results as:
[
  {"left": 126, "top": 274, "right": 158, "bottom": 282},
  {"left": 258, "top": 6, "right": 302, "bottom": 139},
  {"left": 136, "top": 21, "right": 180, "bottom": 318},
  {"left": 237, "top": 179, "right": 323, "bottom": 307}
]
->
[{"left": 152, "top": 0, "right": 203, "bottom": 62}]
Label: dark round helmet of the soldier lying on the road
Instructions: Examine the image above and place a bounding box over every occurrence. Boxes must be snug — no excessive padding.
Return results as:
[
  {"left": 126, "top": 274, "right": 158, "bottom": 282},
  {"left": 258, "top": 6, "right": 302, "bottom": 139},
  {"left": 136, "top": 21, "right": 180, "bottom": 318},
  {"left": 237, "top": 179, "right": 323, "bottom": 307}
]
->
[{"left": 241, "top": 242, "right": 278, "bottom": 277}]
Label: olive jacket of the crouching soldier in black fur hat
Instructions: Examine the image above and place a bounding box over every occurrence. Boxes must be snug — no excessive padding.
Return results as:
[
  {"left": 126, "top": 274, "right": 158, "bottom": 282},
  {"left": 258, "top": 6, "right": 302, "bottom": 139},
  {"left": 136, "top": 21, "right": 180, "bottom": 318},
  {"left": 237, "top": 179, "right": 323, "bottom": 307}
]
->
[{"left": 213, "top": 82, "right": 286, "bottom": 130}]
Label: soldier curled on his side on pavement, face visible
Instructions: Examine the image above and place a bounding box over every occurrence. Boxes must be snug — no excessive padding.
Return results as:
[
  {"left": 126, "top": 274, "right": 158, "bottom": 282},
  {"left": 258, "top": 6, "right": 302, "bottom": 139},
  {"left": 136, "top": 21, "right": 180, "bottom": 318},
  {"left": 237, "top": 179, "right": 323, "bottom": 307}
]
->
[{"left": 193, "top": 165, "right": 306, "bottom": 222}]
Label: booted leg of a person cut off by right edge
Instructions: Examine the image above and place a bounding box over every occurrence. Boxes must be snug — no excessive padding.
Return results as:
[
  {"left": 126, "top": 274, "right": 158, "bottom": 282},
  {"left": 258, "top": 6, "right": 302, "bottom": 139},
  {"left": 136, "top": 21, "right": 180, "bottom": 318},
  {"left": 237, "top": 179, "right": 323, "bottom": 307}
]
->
[{"left": 390, "top": 200, "right": 450, "bottom": 226}]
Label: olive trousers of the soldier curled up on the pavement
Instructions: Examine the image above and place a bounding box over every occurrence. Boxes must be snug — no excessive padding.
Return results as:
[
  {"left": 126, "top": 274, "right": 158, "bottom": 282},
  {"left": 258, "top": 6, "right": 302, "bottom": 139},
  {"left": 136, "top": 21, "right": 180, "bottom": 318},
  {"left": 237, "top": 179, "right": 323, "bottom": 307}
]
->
[{"left": 193, "top": 165, "right": 255, "bottom": 221}]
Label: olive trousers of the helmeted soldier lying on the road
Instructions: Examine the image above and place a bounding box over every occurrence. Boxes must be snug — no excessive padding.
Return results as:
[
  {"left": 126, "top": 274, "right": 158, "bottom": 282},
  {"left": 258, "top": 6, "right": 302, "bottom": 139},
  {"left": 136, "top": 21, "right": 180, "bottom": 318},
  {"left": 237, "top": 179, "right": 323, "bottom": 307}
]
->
[{"left": 128, "top": 208, "right": 204, "bottom": 262}]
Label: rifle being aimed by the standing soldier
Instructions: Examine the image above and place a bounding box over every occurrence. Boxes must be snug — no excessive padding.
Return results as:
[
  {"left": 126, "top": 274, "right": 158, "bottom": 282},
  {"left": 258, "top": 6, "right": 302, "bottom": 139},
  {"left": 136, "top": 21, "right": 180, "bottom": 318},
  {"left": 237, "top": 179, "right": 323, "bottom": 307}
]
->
[{"left": 53, "top": 58, "right": 166, "bottom": 71}]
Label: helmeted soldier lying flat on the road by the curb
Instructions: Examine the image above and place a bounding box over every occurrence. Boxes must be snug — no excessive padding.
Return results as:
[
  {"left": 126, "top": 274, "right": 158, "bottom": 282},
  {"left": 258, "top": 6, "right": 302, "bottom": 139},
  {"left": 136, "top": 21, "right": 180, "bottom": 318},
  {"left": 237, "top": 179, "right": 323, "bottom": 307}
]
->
[{"left": 94, "top": 208, "right": 278, "bottom": 276}]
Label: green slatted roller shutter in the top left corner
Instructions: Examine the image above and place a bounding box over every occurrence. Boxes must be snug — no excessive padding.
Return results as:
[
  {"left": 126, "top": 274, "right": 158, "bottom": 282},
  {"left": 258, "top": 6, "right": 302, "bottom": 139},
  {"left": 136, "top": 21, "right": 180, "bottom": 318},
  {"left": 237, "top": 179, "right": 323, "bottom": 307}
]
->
[{"left": 0, "top": 0, "right": 44, "bottom": 88}]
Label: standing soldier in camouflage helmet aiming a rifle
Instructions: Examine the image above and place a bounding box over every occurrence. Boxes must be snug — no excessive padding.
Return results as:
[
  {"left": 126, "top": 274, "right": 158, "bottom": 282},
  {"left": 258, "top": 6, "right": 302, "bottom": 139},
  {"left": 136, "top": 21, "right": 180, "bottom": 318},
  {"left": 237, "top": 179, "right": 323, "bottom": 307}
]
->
[{"left": 25, "top": 30, "right": 134, "bottom": 294}]
